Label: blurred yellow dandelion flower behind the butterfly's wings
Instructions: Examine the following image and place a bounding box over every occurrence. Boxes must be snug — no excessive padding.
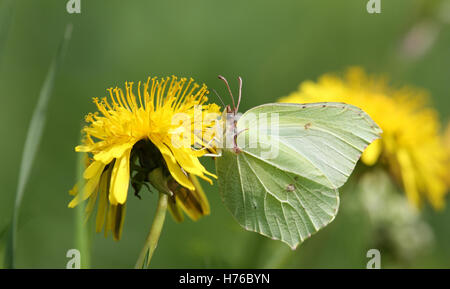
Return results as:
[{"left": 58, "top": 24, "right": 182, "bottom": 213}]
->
[{"left": 280, "top": 67, "right": 448, "bottom": 208}]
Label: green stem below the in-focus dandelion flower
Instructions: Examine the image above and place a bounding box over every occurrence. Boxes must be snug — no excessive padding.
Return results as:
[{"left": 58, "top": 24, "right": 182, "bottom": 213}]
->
[{"left": 135, "top": 193, "right": 168, "bottom": 269}]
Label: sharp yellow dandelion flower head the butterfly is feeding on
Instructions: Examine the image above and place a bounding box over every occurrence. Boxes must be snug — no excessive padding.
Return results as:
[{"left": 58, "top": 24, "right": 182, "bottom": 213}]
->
[{"left": 69, "top": 76, "right": 220, "bottom": 240}]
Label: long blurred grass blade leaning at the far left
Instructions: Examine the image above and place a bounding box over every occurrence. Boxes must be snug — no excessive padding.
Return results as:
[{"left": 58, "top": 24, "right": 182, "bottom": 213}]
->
[{"left": 6, "top": 24, "right": 72, "bottom": 268}]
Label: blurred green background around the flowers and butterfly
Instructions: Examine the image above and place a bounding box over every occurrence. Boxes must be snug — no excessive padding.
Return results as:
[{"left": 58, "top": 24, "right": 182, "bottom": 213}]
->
[{"left": 0, "top": 0, "right": 450, "bottom": 268}]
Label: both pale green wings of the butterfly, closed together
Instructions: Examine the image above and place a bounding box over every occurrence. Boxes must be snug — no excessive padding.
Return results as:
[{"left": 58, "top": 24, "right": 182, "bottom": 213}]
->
[{"left": 216, "top": 103, "right": 381, "bottom": 248}]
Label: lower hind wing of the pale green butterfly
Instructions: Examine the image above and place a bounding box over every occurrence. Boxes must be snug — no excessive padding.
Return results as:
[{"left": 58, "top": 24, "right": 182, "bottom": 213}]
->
[{"left": 216, "top": 150, "right": 339, "bottom": 248}]
